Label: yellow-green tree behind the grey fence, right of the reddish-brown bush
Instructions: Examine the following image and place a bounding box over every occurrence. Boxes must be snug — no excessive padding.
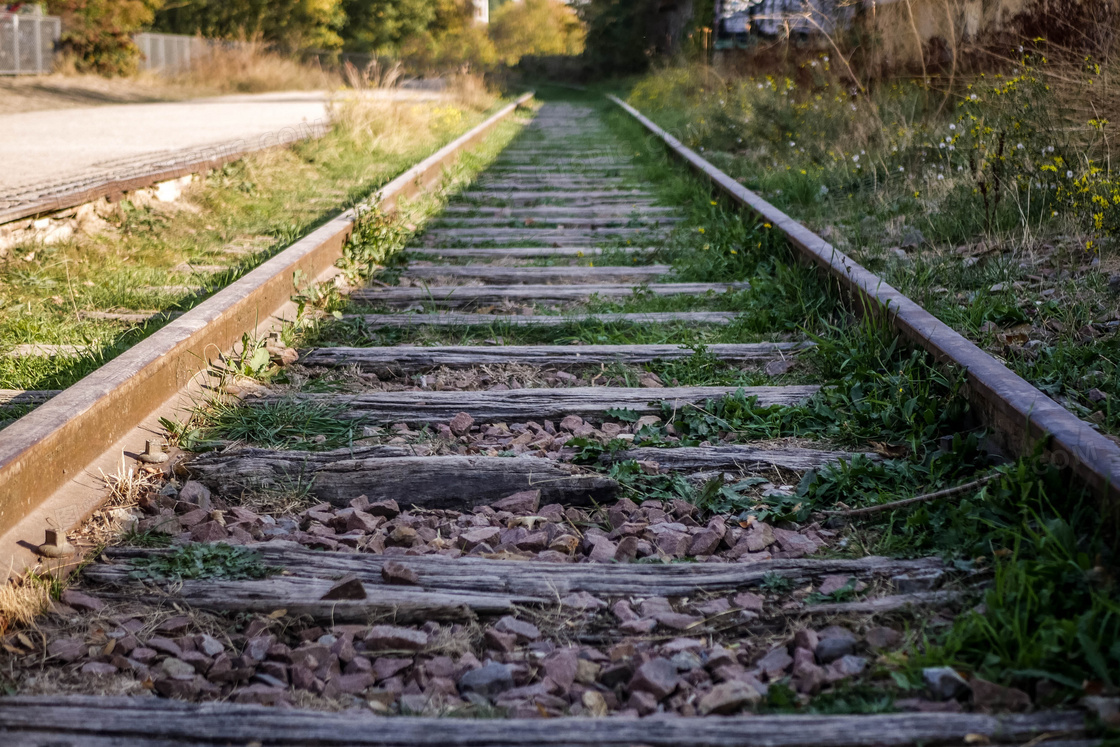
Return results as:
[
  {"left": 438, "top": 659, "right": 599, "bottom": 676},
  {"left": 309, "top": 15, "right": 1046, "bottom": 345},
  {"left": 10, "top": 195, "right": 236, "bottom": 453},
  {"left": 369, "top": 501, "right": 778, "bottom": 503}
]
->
[{"left": 155, "top": 0, "right": 346, "bottom": 52}]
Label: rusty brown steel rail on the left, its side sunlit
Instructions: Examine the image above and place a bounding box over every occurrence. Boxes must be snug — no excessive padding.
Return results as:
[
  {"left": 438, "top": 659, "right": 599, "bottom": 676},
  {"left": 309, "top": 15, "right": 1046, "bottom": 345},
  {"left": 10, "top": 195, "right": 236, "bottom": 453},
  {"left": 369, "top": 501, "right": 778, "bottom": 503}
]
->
[{"left": 0, "top": 93, "right": 533, "bottom": 551}]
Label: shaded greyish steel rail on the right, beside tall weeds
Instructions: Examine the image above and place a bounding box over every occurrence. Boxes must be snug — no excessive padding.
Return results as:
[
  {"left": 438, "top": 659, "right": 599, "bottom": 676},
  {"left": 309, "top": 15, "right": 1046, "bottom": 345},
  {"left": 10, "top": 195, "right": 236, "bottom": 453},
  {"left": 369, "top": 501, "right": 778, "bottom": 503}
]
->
[{"left": 608, "top": 95, "right": 1120, "bottom": 517}]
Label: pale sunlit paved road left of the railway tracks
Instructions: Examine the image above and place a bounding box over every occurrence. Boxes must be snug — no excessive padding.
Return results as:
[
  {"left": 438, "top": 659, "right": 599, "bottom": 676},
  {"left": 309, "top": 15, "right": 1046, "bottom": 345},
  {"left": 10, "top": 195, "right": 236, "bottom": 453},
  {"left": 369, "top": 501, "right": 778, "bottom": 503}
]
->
[{"left": 0, "top": 92, "right": 329, "bottom": 200}]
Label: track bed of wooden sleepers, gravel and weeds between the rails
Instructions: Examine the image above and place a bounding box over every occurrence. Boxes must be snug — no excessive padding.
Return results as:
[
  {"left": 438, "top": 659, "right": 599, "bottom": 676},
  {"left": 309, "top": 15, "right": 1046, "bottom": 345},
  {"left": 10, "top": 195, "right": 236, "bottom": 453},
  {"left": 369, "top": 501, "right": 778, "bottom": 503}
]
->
[{"left": 0, "top": 103, "right": 1099, "bottom": 747}]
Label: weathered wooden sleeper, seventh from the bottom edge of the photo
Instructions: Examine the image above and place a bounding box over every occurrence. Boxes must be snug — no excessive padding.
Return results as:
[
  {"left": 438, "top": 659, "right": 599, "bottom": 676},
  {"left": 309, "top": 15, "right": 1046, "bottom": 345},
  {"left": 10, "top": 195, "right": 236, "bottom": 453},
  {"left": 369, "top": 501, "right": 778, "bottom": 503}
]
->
[{"left": 351, "top": 282, "right": 750, "bottom": 308}]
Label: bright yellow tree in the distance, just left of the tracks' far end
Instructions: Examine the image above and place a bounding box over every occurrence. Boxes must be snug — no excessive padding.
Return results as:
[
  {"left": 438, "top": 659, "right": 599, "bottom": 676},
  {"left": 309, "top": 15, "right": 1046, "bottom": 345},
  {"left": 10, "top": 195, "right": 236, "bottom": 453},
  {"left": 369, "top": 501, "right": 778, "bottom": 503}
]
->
[{"left": 489, "top": 0, "right": 586, "bottom": 65}]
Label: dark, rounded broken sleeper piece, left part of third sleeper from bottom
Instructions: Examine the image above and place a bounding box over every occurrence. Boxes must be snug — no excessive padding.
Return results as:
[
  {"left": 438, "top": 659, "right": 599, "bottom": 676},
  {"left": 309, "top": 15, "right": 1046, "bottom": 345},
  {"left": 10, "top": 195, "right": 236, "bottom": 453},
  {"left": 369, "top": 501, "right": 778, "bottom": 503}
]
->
[{"left": 188, "top": 447, "right": 618, "bottom": 510}]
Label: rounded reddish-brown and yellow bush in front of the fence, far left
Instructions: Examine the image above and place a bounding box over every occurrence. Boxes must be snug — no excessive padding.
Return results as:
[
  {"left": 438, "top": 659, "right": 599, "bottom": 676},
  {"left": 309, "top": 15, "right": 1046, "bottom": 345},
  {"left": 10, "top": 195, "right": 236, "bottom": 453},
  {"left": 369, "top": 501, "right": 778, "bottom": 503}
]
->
[{"left": 47, "top": 0, "right": 164, "bottom": 75}]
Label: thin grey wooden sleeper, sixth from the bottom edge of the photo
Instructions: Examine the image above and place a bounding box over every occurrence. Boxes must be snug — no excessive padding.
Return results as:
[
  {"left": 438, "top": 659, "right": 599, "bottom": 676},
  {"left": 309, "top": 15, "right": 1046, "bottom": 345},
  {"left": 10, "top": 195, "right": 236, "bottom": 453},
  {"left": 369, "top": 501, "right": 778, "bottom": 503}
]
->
[{"left": 343, "top": 311, "right": 738, "bottom": 328}]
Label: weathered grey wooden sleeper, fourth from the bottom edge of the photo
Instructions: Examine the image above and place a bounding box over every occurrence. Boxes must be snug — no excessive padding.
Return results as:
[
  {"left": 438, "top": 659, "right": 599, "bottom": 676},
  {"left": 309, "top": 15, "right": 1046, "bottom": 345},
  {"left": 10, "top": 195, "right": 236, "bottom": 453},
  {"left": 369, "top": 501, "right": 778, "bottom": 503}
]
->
[{"left": 252, "top": 385, "right": 820, "bottom": 423}]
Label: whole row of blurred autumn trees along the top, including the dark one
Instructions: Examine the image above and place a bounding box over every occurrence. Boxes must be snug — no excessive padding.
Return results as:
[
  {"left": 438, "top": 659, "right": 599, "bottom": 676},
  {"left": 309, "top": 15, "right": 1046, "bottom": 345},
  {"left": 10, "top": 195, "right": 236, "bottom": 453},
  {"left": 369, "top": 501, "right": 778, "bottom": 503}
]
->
[{"left": 39, "top": 0, "right": 712, "bottom": 75}]
